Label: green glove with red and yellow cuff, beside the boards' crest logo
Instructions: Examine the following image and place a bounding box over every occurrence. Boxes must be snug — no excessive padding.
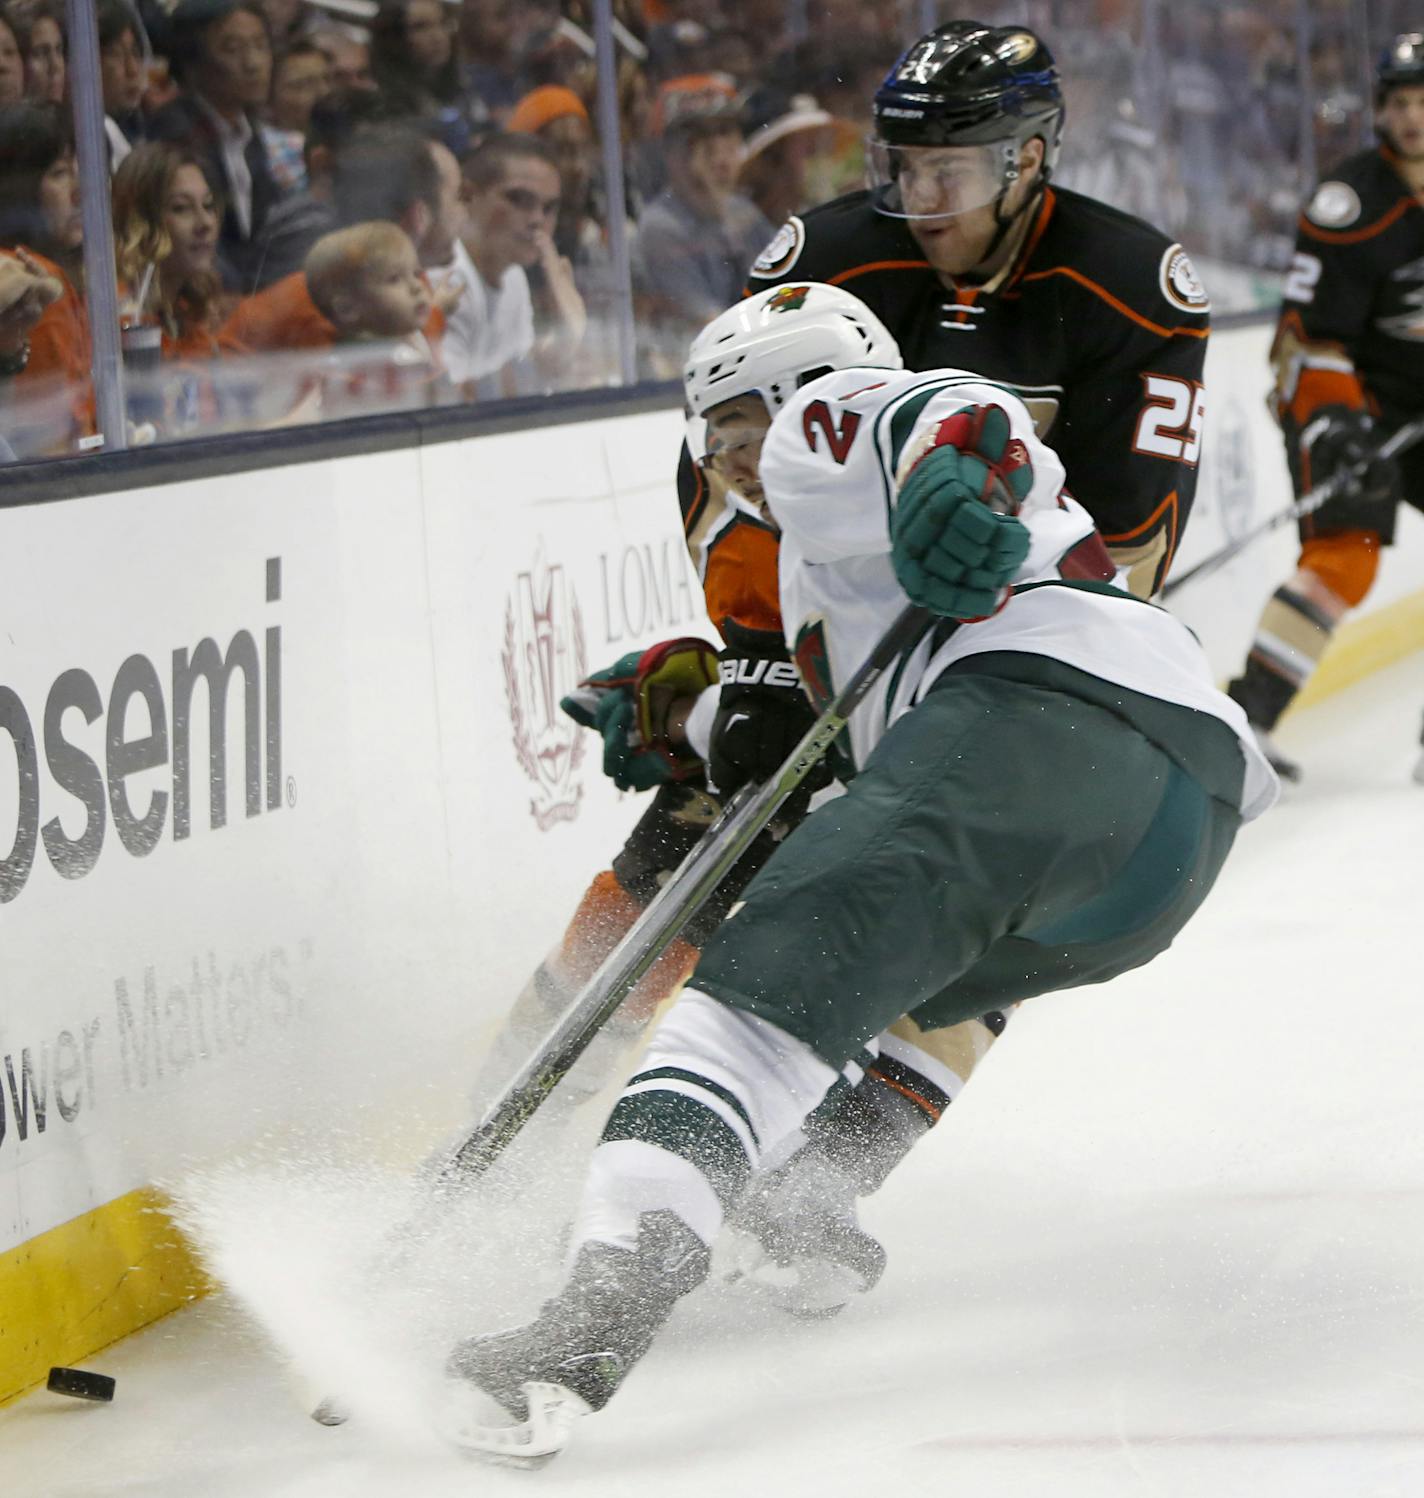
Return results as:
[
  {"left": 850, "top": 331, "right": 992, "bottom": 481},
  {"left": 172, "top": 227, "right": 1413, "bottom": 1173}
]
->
[{"left": 559, "top": 637, "right": 717, "bottom": 791}]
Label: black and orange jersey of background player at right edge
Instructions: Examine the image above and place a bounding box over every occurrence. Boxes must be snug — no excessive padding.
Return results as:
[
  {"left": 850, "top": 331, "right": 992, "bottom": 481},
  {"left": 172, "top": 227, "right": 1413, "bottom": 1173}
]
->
[{"left": 1271, "top": 145, "right": 1424, "bottom": 437}]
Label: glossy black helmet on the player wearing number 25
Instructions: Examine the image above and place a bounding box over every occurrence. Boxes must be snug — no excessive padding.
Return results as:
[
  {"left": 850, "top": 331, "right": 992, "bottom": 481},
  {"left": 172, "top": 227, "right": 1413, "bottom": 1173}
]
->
[{"left": 871, "top": 21, "right": 1063, "bottom": 178}]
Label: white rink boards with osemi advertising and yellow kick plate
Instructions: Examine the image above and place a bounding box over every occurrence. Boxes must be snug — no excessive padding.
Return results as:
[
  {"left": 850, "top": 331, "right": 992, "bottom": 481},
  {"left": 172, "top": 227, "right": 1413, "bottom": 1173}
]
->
[{"left": 0, "top": 330, "right": 1424, "bottom": 1399}]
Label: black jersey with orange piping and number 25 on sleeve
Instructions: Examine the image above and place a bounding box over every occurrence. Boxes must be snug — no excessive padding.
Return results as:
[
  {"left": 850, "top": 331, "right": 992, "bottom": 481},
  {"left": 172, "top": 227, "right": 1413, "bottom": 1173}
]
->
[{"left": 749, "top": 189, "right": 1208, "bottom": 593}]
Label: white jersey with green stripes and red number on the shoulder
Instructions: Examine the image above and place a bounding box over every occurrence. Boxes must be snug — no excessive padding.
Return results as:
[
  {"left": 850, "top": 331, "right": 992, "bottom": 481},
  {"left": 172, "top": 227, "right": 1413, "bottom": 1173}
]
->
[{"left": 761, "top": 369, "right": 1276, "bottom": 818}]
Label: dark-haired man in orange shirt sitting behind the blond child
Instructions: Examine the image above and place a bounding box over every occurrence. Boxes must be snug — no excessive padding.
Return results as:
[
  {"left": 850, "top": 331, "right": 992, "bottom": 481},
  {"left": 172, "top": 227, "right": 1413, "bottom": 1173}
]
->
[{"left": 223, "top": 124, "right": 460, "bottom": 352}]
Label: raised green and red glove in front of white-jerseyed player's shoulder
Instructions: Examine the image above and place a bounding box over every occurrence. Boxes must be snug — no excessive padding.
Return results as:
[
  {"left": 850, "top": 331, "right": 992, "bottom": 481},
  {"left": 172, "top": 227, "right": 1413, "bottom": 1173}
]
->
[{"left": 891, "top": 406, "right": 1033, "bottom": 619}]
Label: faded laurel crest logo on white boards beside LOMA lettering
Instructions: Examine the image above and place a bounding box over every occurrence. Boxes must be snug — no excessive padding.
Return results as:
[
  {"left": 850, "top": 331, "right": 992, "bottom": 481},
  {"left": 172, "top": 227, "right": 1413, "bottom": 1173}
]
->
[{"left": 500, "top": 557, "right": 588, "bottom": 831}]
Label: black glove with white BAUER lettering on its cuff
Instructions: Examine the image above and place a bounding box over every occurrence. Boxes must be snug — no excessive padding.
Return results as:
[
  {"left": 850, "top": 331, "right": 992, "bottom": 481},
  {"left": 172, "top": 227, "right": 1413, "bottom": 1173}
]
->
[{"left": 707, "top": 643, "right": 830, "bottom": 795}]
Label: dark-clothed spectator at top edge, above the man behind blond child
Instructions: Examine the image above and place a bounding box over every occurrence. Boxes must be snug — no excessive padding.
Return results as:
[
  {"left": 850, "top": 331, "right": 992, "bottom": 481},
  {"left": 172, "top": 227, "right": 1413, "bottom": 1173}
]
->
[{"left": 371, "top": 0, "right": 490, "bottom": 156}]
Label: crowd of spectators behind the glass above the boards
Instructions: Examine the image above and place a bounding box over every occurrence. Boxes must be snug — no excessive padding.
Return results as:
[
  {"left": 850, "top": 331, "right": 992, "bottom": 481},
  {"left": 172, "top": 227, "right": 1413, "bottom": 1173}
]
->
[{"left": 0, "top": 0, "right": 1408, "bottom": 460}]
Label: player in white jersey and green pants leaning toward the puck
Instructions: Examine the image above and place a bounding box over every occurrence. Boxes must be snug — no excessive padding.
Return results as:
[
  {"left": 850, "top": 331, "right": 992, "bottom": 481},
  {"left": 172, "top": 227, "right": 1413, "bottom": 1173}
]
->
[{"left": 448, "top": 283, "right": 1279, "bottom": 1462}]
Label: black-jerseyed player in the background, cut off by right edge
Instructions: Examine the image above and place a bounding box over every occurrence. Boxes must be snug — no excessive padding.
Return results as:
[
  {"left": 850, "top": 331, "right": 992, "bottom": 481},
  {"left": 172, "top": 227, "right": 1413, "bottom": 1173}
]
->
[{"left": 1231, "top": 31, "right": 1424, "bottom": 779}]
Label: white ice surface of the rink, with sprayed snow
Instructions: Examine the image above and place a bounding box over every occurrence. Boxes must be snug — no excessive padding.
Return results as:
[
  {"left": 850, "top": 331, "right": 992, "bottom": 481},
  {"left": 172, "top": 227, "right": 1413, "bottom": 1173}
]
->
[{"left": 8, "top": 655, "right": 1424, "bottom": 1498}]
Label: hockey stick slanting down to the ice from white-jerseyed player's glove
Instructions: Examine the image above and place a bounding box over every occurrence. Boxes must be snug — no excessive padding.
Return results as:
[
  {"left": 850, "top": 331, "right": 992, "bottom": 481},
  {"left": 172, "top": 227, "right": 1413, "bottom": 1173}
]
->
[{"left": 422, "top": 605, "right": 933, "bottom": 1194}]
